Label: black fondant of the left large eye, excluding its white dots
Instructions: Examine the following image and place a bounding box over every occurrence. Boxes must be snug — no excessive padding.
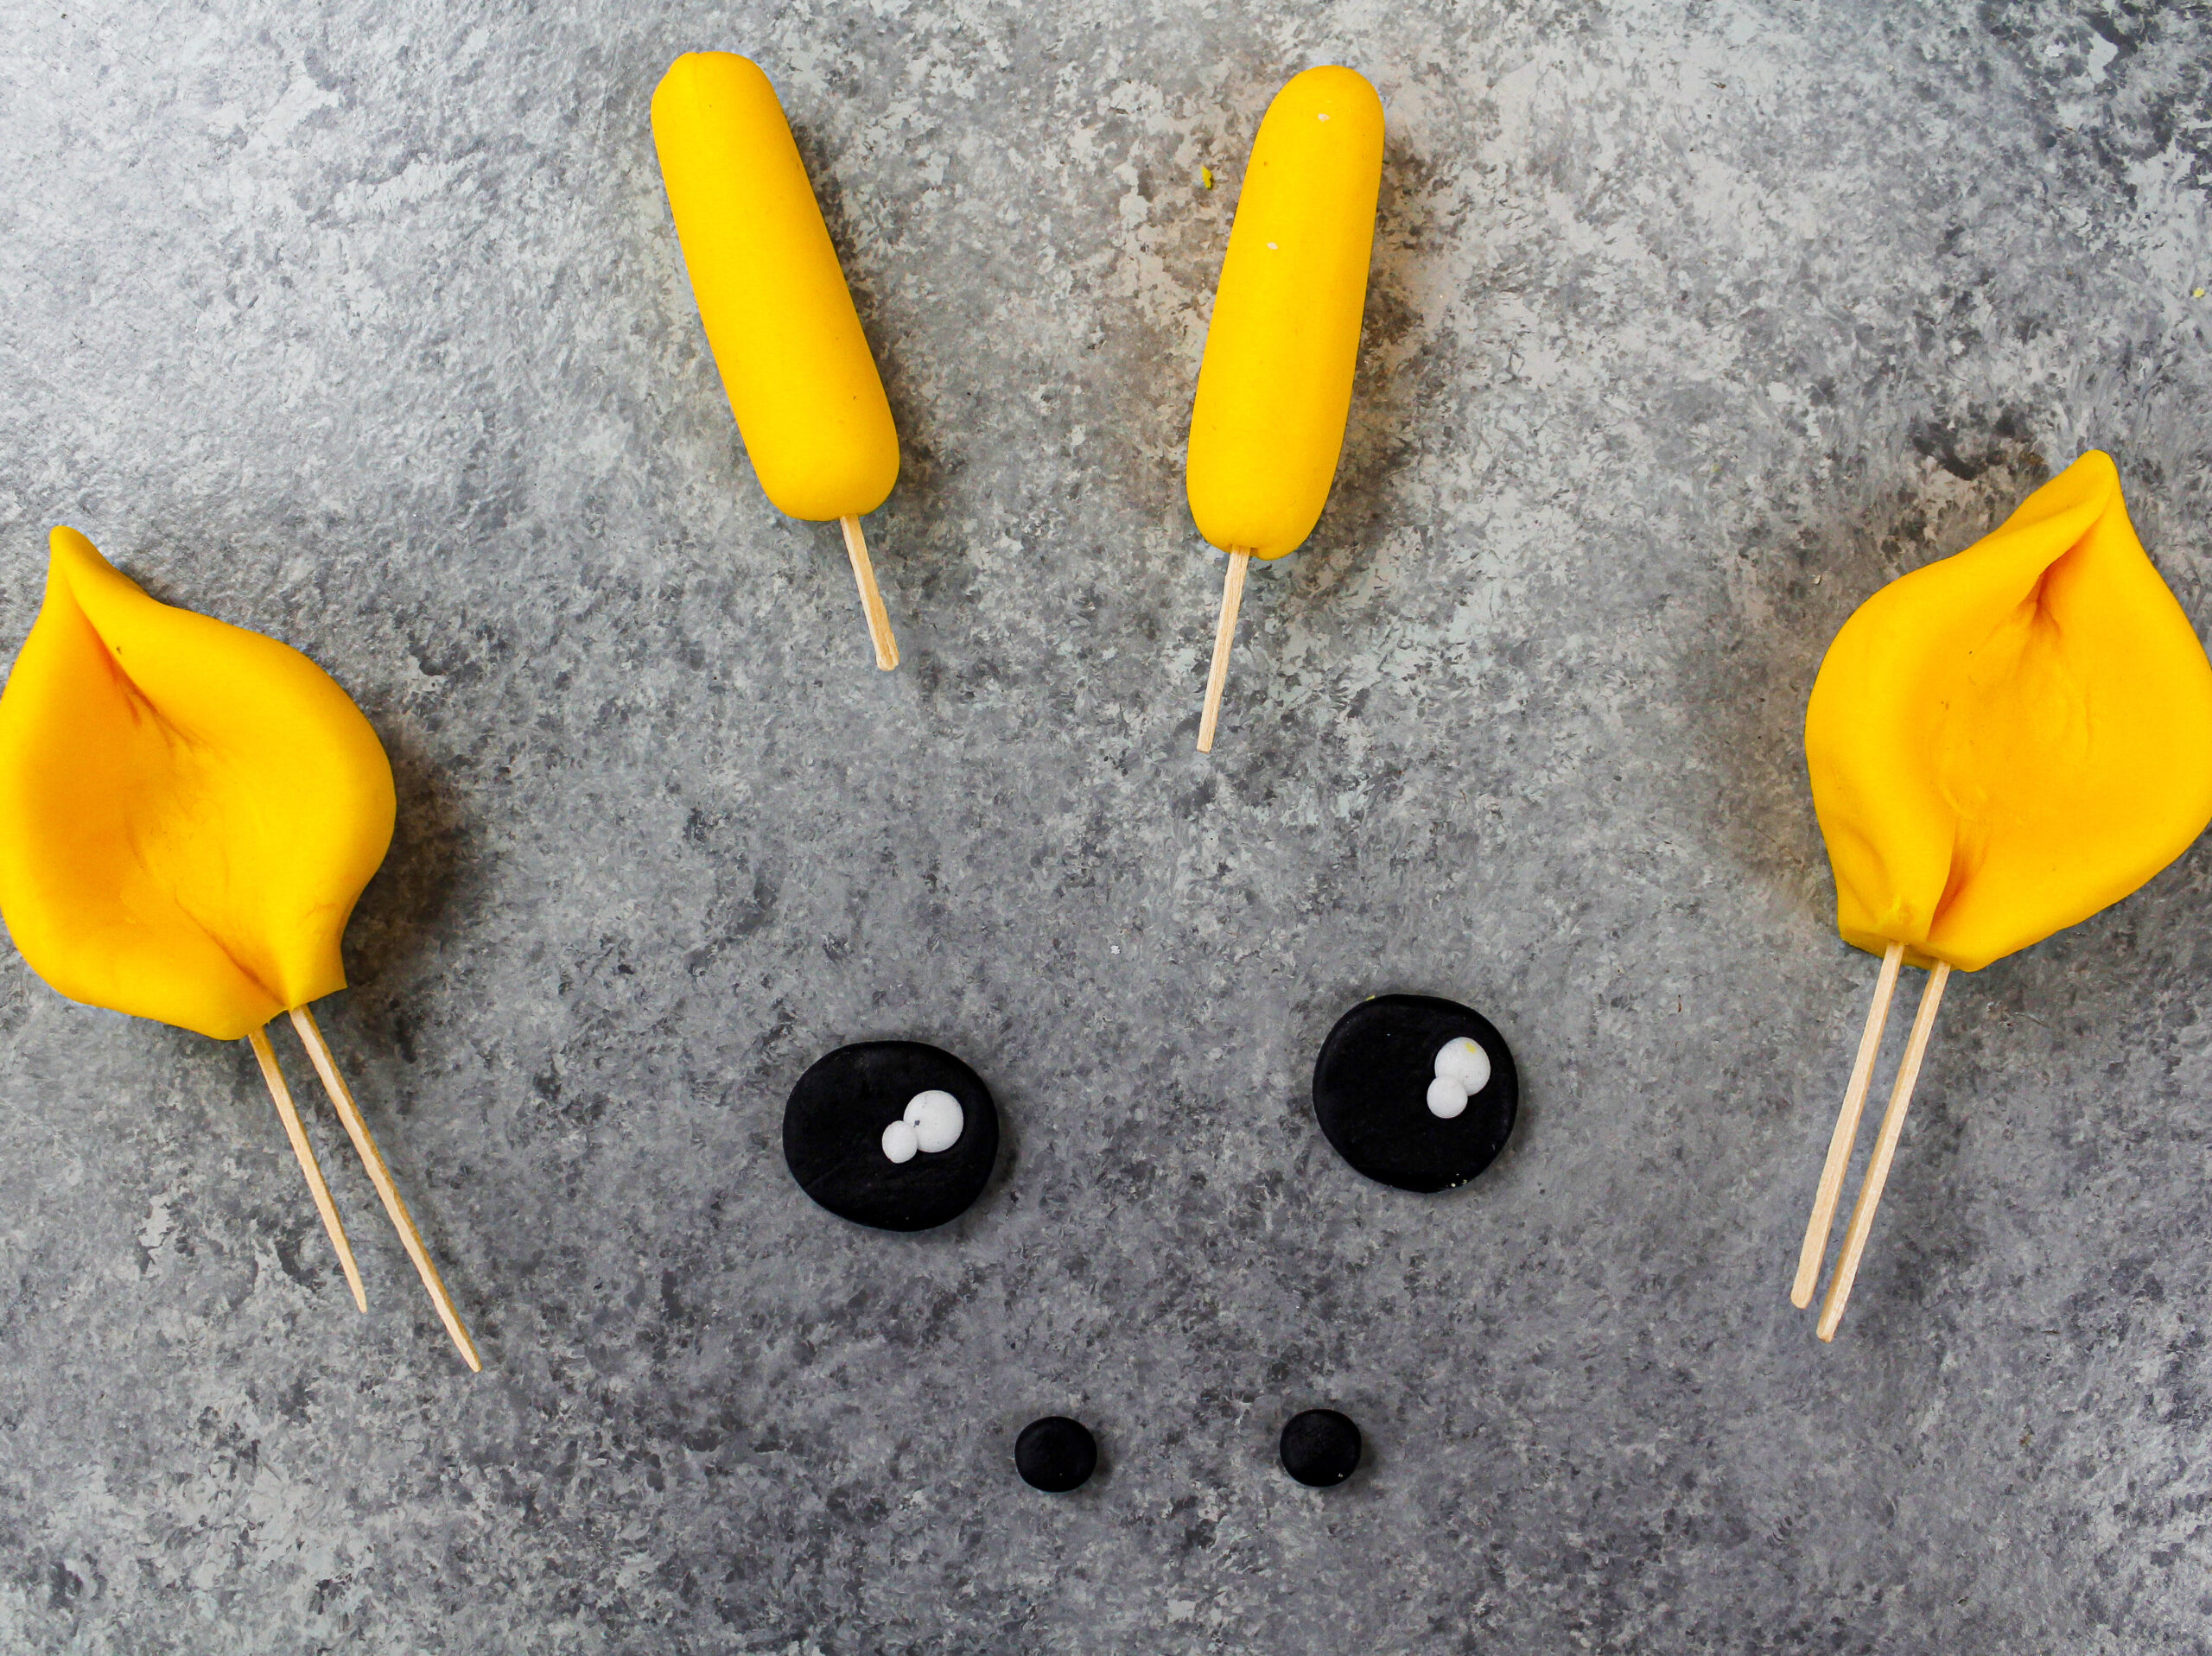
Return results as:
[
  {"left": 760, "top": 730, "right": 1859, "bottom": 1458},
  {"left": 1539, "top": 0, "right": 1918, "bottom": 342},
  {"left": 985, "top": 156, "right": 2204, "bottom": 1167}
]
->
[{"left": 783, "top": 1041, "right": 998, "bottom": 1232}]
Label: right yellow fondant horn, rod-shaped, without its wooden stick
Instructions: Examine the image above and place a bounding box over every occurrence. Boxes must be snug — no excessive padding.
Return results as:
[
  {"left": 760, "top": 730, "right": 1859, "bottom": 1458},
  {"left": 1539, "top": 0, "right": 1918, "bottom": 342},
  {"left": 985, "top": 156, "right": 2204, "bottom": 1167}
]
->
[{"left": 1185, "top": 67, "right": 1382, "bottom": 557}]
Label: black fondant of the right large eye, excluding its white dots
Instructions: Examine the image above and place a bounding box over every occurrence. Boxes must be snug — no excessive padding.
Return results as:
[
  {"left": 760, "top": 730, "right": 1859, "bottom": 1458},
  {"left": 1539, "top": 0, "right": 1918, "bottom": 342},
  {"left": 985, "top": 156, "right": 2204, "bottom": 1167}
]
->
[{"left": 1314, "top": 995, "right": 1520, "bottom": 1192}]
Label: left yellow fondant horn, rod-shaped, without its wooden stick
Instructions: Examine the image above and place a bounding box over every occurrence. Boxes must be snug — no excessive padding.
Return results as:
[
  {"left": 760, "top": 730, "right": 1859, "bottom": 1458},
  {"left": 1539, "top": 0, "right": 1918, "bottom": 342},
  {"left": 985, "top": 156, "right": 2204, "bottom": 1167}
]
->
[{"left": 652, "top": 51, "right": 898, "bottom": 519}]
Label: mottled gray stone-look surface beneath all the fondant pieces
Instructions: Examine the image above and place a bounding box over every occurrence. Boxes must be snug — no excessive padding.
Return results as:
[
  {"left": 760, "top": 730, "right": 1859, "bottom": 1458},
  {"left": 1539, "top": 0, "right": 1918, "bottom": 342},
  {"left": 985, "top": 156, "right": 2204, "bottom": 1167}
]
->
[{"left": 0, "top": 0, "right": 2212, "bottom": 1653}]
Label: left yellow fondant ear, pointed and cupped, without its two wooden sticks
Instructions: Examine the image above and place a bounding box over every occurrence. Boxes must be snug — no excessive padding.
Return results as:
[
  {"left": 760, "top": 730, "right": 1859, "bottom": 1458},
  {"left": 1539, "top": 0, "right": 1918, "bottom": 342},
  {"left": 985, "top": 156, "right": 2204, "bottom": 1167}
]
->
[{"left": 0, "top": 529, "right": 394, "bottom": 1039}]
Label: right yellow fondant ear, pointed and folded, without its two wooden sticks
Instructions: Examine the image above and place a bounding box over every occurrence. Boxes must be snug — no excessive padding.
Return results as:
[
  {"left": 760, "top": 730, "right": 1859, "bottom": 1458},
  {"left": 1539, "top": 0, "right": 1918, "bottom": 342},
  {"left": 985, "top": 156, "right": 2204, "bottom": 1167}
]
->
[{"left": 1805, "top": 451, "right": 2212, "bottom": 971}]
